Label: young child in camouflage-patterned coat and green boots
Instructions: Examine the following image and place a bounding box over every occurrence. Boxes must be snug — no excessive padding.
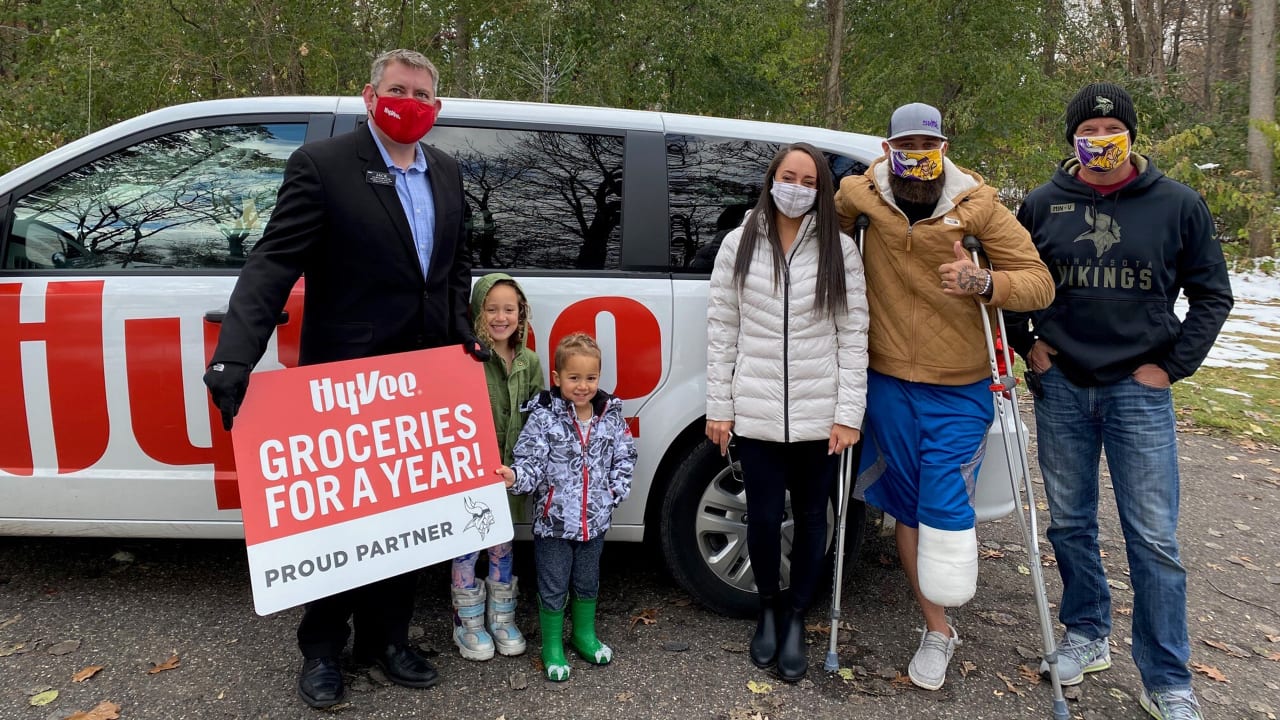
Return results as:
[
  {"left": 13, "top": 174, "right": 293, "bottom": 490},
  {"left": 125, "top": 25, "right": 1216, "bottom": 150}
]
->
[{"left": 498, "top": 333, "right": 636, "bottom": 682}]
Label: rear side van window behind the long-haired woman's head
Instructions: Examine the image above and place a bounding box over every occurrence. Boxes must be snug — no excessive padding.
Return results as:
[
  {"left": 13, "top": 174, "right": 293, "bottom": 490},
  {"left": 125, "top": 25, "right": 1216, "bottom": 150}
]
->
[{"left": 667, "top": 135, "right": 867, "bottom": 273}]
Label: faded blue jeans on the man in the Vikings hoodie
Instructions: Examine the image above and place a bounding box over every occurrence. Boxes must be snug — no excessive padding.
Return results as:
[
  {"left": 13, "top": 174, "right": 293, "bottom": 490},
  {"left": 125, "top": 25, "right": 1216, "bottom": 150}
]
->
[{"left": 1036, "top": 368, "right": 1192, "bottom": 692}]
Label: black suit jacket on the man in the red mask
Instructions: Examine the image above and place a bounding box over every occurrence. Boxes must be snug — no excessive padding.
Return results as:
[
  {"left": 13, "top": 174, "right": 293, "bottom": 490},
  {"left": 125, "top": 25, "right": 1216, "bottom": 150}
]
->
[{"left": 212, "top": 127, "right": 471, "bottom": 366}]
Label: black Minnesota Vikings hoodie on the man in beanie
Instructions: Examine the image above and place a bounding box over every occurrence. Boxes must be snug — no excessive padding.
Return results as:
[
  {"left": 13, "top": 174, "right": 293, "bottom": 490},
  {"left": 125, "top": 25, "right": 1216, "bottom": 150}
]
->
[{"left": 1009, "top": 154, "right": 1233, "bottom": 386}]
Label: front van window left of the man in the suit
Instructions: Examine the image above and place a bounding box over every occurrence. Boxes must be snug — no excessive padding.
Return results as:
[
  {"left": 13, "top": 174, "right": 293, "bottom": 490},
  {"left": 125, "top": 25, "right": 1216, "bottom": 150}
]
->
[{"left": 4, "top": 123, "right": 307, "bottom": 272}]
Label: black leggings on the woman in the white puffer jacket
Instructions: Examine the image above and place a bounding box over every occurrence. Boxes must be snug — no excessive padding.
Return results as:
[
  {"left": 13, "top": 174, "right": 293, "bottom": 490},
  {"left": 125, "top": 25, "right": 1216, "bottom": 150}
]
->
[{"left": 736, "top": 437, "right": 840, "bottom": 611}]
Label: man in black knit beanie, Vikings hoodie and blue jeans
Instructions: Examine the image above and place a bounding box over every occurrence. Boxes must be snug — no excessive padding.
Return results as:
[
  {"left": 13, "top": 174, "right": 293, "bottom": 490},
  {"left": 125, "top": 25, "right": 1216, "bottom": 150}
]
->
[{"left": 1003, "top": 82, "right": 1231, "bottom": 720}]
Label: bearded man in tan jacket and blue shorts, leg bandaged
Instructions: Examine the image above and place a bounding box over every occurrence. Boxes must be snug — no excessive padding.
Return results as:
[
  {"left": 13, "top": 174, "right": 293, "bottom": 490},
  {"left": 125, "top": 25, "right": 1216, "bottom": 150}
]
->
[{"left": 836, "top": 102, "right": 1053, "bottom": 689}]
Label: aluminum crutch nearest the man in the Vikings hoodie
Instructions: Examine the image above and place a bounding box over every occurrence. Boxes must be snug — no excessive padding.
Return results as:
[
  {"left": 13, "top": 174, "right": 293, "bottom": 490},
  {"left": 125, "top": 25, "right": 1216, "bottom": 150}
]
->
[{"left": 964, "top": 234, "right": 1069, "bottom": 720}]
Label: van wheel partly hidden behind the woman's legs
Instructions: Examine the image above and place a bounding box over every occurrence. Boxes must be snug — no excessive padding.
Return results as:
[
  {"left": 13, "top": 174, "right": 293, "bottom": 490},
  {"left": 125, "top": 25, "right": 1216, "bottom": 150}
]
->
[{"left": 659, "top": 441, "right": 867, "bottom": 618}]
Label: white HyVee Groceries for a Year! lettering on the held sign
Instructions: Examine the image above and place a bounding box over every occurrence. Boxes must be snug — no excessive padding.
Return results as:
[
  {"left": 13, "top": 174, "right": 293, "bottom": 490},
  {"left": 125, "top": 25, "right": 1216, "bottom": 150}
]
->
[{"left": 259, "top": 370, "right": 483, "bottom": 528}]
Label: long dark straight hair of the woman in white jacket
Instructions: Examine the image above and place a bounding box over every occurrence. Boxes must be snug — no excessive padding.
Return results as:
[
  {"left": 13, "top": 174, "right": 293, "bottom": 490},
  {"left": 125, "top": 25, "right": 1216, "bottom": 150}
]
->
[{"left": 733, "top": 142, "right": 849, "bottom": 318}]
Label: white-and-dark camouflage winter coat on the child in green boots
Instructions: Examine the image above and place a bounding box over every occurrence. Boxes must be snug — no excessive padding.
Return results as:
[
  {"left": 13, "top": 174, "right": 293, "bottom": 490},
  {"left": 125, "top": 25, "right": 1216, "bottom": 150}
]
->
[{"left": 511, "top": 388, "right": 636, "bottom": 541}]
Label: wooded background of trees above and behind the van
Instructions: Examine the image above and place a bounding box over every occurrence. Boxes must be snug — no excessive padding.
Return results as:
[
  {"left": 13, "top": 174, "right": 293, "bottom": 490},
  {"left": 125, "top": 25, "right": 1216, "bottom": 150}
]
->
[{"left": 0, "top": 0, "right": 1280, "bottom": 256}]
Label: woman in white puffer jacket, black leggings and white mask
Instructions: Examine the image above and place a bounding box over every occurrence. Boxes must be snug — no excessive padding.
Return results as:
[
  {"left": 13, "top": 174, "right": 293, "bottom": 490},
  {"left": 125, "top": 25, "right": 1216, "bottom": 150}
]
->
[{"left": 707, "top": 142, "right": 868, "bottom": 682}]
